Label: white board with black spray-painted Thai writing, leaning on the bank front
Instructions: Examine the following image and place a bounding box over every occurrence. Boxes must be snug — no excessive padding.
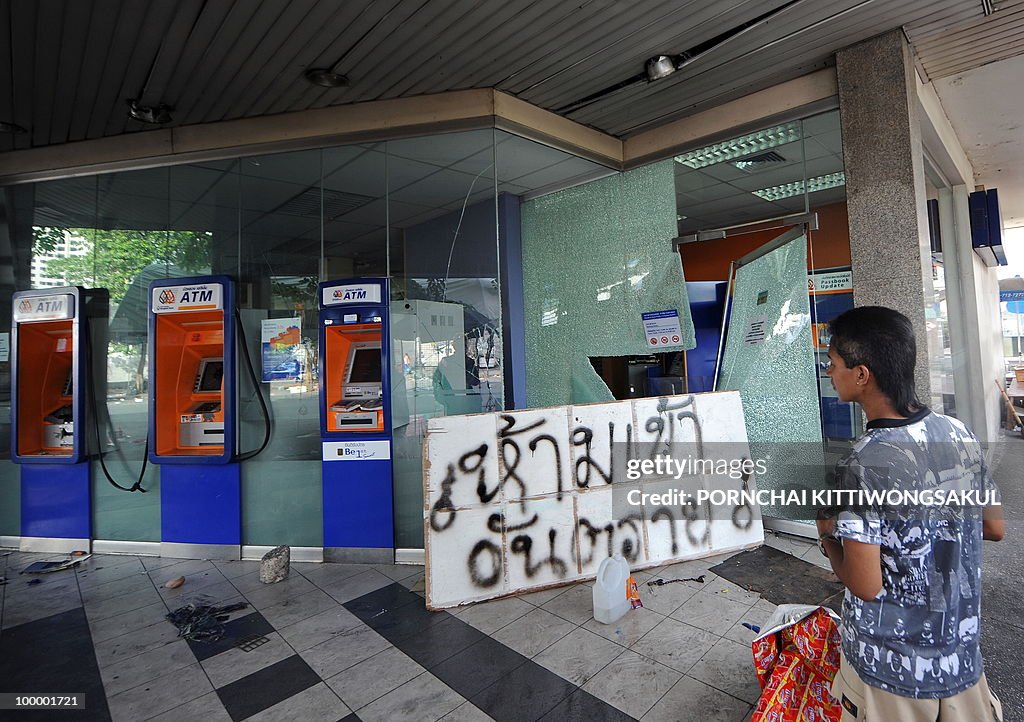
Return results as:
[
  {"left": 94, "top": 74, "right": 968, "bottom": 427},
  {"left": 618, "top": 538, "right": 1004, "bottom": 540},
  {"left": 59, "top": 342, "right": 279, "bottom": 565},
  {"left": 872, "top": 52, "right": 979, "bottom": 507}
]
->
[{"left": 423, "top": 391, "right": 764, "bottom": 608}]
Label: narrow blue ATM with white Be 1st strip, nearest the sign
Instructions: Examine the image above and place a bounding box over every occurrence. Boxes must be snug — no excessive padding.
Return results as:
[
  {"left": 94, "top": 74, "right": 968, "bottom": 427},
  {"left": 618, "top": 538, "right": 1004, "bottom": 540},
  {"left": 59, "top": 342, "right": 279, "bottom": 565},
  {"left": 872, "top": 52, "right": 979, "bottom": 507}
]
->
[{"left": 318, "top": 279, "right": 394, "bottom": 563}]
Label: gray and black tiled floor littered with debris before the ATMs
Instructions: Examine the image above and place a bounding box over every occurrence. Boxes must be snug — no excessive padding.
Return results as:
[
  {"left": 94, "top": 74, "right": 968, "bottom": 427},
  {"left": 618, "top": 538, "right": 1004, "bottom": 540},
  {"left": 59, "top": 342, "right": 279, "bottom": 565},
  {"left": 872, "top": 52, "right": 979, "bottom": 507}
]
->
[{"left": 0, "top": 537, "right": 818, "bottom": 722}]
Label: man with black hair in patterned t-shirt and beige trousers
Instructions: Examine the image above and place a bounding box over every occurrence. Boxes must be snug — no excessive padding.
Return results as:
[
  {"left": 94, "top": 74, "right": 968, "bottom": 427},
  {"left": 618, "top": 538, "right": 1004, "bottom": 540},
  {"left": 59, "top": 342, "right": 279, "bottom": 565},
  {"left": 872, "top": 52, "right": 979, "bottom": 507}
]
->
[{"left": 818, "top": 306, "right": 1004, "bottom": 722}]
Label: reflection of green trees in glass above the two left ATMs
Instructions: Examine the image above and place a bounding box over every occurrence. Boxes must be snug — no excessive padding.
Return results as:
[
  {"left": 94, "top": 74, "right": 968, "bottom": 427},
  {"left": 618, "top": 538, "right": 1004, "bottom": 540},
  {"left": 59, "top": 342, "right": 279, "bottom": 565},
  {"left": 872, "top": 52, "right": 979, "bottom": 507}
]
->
[{"left": 33, "top": 227, "right": 213, "bottom": 304}]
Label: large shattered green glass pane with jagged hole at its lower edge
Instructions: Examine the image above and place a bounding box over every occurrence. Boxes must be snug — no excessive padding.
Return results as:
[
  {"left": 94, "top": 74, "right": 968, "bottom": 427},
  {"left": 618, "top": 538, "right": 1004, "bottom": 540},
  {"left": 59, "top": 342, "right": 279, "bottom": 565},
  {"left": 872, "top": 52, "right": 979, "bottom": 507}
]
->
[{"left": 522, "top": 161, "right": 694, "bottom": 407}]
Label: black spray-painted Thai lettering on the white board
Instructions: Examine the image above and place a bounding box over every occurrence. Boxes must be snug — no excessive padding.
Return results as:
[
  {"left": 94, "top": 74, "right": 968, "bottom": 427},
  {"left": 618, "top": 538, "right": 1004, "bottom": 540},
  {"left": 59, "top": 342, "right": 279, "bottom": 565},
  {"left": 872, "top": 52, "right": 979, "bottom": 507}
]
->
[{"left": 429, "top": 395, "right": 754, "bottom": 589}]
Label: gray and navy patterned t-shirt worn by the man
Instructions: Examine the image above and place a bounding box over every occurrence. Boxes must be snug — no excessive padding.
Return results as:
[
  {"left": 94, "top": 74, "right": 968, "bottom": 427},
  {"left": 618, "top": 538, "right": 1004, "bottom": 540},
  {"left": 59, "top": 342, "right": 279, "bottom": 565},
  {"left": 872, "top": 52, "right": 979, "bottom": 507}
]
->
[{"left": 836, "top": 409, "right": 998, "bottom": 698}]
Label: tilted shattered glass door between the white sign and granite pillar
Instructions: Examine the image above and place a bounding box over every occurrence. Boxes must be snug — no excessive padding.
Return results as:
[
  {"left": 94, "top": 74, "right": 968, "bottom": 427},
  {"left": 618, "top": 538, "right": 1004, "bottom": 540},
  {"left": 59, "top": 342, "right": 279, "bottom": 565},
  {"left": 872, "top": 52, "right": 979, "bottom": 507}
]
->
[{"left": 717, "top": 231, "right": 823, "bottom": 517}]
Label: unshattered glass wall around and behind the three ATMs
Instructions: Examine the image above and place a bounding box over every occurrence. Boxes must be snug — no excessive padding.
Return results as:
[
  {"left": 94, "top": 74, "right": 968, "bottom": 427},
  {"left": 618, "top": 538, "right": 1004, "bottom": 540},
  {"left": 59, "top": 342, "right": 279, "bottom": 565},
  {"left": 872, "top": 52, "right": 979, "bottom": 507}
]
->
[{"left": 0, "top": 129, "right": 603, "bottom": 548}]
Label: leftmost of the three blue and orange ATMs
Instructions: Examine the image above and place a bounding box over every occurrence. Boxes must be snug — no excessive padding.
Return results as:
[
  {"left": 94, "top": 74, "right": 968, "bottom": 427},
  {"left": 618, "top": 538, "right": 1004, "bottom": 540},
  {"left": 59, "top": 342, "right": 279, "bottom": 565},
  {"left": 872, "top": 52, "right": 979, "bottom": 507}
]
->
[{"left": 11, "top": 287, "right": 110, "bottom": 553}]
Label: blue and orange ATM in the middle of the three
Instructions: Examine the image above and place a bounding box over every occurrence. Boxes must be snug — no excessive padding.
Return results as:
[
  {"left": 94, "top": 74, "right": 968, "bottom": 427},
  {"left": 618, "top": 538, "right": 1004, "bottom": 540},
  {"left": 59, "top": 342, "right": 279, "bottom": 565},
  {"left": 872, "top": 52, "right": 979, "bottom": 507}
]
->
[{"left": 148, "top": 275, "right": 242, "bottom": 559}]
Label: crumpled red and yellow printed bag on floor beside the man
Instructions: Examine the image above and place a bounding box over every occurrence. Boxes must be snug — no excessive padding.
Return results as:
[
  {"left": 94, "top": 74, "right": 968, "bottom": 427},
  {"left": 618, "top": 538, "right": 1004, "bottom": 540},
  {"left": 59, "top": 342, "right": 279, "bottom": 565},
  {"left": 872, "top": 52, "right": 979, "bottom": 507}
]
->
[{"left": 744, "top": 604, "right": 843, "bottom": 722}]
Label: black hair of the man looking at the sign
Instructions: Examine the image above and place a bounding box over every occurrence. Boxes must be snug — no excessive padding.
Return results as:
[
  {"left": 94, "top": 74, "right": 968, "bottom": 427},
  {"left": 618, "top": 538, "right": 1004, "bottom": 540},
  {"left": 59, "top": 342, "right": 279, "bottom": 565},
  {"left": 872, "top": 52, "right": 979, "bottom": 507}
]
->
[{"left": 828, "top": 306, "right": 924, "bottom": 416}]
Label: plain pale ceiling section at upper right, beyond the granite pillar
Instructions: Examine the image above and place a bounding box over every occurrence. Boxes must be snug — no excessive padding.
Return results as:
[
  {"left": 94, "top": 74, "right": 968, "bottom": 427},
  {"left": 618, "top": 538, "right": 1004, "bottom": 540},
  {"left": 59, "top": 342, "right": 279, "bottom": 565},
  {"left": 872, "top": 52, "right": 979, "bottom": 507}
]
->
[{"left": 932, "top": 55, "right": 1024, "bottom": 228}]
